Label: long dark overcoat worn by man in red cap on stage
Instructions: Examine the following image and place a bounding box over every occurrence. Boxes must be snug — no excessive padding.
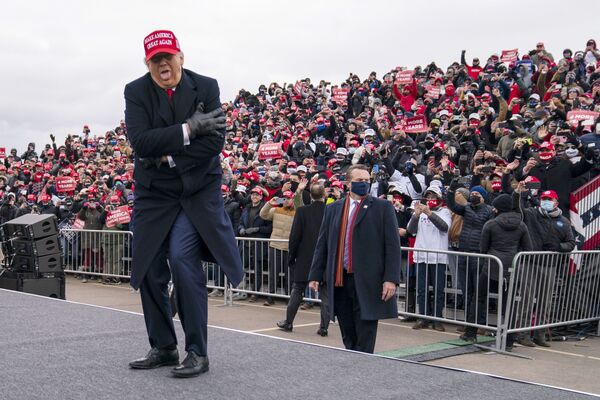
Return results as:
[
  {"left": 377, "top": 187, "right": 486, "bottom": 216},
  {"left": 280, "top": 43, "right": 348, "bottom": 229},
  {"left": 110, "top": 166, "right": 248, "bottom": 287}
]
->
[{"left": 125, "top": 70, "right": 243, "bottom": 288}]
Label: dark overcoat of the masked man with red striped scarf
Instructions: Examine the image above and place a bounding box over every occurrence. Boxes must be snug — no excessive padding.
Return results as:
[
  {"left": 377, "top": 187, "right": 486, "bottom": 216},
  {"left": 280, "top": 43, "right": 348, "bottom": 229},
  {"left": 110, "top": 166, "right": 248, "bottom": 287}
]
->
[{"left": 308, "top": 196, "right": 400, "bottom": 320}]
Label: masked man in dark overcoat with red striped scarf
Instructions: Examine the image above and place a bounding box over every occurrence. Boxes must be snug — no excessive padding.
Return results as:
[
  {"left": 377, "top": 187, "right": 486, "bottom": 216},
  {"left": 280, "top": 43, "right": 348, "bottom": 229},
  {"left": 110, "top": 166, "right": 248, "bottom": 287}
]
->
[{"left": 308, "top": 164, "right": 400, "bottom": 353}]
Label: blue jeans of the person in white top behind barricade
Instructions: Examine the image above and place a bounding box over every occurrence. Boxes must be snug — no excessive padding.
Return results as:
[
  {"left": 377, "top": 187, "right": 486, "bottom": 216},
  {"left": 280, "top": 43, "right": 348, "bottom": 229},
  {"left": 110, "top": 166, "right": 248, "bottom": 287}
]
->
[{"left": 417, "top": 263, "right": 446, "bottom": 317}]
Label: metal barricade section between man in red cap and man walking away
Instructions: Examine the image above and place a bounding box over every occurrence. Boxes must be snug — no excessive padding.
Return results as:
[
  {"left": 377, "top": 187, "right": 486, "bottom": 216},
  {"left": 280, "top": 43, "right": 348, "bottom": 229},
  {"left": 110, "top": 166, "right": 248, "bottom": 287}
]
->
[{"left": 231, "top": 237, "right": 320, "bottom": 302}]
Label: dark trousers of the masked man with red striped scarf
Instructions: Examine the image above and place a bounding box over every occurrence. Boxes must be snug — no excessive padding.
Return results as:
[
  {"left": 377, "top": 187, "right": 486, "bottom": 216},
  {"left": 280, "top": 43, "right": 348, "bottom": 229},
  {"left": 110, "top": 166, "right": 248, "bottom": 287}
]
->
[{"left": 333, "top": 273, "right": 379, "bottom": 353}]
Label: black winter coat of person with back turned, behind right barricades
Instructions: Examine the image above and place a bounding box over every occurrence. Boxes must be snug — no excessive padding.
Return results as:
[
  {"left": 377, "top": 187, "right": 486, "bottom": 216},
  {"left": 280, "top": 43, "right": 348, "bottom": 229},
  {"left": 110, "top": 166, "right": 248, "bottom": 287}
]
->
[{"left": 479, "top": 211, "right": 533, "bottom": 280}]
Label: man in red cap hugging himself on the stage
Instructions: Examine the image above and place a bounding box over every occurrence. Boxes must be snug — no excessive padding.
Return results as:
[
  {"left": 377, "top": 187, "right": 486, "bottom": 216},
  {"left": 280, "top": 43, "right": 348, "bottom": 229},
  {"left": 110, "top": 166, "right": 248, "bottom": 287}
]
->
[{"left": 125, "top": 31, "right": 243, "bottom": 377}]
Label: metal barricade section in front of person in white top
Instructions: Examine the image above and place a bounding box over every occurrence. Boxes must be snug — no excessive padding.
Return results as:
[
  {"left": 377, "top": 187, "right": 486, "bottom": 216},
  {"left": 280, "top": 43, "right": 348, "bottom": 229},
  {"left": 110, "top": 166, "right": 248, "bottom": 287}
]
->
[{"left": 398, "top": 247, "right": 504, "bottom": 349}]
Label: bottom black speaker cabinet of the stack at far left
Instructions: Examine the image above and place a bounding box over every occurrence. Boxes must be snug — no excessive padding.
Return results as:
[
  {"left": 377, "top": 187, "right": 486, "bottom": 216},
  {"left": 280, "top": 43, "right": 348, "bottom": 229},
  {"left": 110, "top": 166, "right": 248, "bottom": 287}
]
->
[{"left": 0, "top": 271, "right": 65, "bottom": 300}]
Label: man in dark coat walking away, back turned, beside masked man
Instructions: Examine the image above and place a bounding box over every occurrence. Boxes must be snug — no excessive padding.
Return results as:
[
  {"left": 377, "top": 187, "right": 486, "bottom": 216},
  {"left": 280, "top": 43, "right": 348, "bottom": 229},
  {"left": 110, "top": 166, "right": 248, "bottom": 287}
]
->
[{"left": 277, "top": 184, "right": 329, "bottom": 336}]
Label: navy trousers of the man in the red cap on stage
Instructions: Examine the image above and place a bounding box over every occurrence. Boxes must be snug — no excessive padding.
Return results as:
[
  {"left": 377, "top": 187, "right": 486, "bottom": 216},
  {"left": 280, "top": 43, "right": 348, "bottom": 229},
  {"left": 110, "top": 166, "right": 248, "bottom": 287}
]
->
[{"left": 140, "top": 210, "right": 208, "bottom": 356}]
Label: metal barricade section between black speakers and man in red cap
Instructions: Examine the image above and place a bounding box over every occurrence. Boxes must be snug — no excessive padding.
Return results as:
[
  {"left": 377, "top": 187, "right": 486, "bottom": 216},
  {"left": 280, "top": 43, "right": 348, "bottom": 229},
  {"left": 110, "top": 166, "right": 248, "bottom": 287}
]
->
[{"left": 60, "top": 229, "right": 133, "bottom": 279}]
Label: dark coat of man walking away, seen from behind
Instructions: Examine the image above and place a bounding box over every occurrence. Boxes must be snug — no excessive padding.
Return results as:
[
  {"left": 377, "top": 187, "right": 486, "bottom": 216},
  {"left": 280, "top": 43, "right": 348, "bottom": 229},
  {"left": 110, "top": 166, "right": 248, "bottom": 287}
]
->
[{"left": 288, "top": 201, "right": 325, "bottom": 282}]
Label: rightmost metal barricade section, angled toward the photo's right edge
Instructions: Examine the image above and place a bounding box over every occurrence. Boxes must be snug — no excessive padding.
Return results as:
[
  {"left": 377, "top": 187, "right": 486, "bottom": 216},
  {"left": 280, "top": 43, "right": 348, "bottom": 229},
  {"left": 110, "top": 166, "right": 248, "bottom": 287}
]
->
[{"left": 501, "top": 250, "right": 600, "bottom": 350}]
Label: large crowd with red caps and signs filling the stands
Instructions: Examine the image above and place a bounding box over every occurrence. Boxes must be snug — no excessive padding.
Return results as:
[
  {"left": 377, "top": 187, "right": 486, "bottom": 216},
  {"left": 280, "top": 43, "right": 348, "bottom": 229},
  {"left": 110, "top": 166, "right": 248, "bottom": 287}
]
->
[{"left": 0, "top": 39, "right": 600, "bottom": 343}]
